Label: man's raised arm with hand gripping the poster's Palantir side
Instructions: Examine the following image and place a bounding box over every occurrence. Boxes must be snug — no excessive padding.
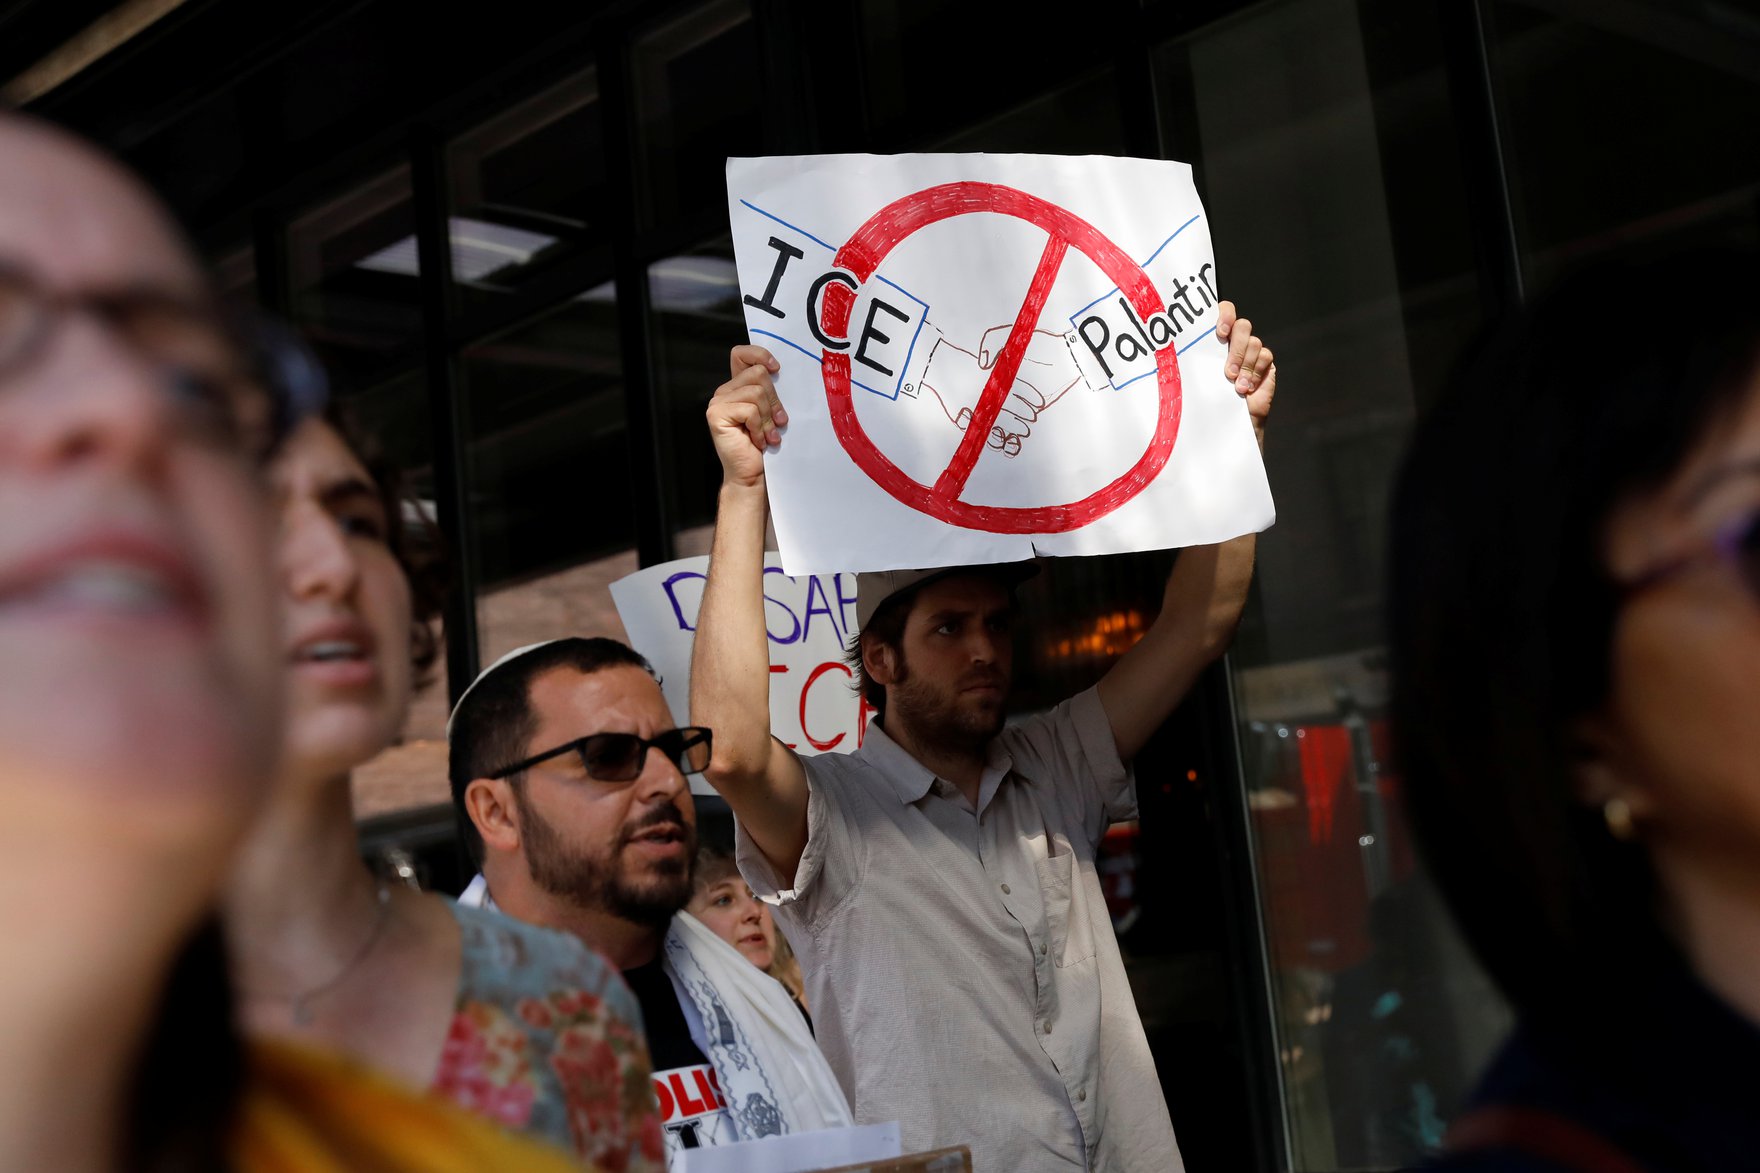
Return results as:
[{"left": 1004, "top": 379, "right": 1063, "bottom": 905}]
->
[{"left": 1098, "top": 301, "right": 1278, "bottom": 761}]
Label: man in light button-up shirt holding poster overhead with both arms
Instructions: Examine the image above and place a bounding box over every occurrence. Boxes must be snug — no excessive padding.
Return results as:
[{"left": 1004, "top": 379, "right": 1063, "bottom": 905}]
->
[{"left": 692, "top": 301, "right": 1276, "bottom": 1171}]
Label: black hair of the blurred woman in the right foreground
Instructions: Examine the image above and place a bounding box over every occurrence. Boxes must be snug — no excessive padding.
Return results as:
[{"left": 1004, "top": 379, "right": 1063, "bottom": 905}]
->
[{"left": 1389, "top": 250, "right": 1760, "bottom": 1022}]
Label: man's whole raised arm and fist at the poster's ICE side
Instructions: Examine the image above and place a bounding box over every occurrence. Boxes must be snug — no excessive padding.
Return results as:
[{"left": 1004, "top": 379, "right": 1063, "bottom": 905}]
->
[{"left": 690, "top": 345, "right": 806, "bottom": 877}]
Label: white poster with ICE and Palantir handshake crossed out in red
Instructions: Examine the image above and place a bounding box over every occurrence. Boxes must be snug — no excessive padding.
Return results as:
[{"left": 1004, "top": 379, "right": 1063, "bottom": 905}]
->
[{"left": 727, "top": 155, "right": 1274, "bottom": 574}]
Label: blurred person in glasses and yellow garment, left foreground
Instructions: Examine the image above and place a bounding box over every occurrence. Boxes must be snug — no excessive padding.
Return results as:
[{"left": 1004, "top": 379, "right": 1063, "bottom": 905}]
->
[{"left": 0, "top": 113, "right": 580, "bottom": 1173}]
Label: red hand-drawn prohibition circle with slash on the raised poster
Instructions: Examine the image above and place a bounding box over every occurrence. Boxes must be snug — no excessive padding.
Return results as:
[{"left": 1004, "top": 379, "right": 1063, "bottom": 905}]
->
[{"left": 820, "top": 181, "right": 1181, "bottom": 534}]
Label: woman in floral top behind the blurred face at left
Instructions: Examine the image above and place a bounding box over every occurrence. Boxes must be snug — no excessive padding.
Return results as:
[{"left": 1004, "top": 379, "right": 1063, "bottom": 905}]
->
[{"left": 224, "top": 412, "right": 664, "bottom": 1169}]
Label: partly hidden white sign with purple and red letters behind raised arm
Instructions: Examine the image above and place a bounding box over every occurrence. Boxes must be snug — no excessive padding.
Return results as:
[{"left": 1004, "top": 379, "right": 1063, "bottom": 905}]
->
[{"left": 611, "top": 553, "right": 873, "bottom": 794}]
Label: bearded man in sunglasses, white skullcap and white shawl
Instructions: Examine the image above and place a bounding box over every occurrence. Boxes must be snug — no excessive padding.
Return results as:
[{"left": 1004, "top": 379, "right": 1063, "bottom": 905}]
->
[{"left": 447, "top": 639, "right": 850, "bottom": 1166}]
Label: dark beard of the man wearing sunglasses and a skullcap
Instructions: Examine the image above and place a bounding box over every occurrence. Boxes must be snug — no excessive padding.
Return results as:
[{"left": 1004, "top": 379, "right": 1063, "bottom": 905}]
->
[{"left": 517, "top": 794, "right": 697, "bottom": 926}]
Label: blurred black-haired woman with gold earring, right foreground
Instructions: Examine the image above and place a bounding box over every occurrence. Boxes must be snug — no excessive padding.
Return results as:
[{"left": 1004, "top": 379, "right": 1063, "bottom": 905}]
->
[{"left": 1389, "top": 241, "right": 1760, "bottom": 1173}]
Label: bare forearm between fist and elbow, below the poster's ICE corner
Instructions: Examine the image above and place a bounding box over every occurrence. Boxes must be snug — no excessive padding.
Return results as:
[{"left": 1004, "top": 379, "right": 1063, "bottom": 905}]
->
[{"left": 690, "top": 483, "right": 771, "bottom": 782}]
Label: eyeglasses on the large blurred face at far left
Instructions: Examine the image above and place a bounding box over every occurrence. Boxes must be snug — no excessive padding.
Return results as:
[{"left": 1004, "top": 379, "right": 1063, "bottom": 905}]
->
[{"left": 0, "top": 261, "right": 327, "bottom": 463}]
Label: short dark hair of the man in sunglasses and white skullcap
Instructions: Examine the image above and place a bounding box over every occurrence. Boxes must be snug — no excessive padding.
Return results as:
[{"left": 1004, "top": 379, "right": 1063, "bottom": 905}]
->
[{"left": 447, "top": 636, "right": 658, "bottom": 865}]
